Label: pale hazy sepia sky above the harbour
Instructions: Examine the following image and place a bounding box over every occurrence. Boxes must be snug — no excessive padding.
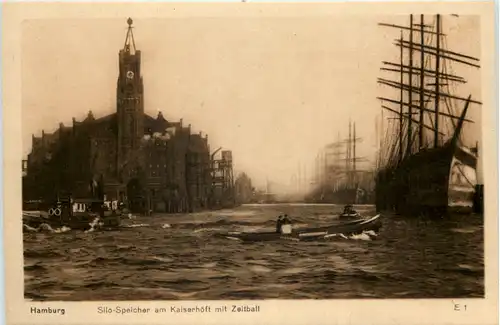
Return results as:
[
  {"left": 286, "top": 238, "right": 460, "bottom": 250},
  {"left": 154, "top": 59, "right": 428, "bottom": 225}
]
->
[{"left": 22, "top": 15, "right": 481, "bottom": 190}]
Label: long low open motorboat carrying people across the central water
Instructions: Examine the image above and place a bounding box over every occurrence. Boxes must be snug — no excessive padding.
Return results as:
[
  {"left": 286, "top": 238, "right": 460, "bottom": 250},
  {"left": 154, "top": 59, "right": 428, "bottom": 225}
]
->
[{"left": 216, "top": 214, "right": 382, "bottom": 242}]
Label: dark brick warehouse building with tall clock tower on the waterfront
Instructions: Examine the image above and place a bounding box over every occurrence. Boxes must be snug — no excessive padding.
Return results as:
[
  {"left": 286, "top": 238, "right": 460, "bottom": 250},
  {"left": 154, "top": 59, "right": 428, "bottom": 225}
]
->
[{"left": 23, "top": 18, "right": 212, "bottom": 212}]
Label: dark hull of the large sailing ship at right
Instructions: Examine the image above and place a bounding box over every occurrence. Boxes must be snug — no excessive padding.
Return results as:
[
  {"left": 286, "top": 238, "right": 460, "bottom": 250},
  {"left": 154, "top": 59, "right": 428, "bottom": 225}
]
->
[{"left": 375, "top": 142, "right": 477, "bottom": 215}]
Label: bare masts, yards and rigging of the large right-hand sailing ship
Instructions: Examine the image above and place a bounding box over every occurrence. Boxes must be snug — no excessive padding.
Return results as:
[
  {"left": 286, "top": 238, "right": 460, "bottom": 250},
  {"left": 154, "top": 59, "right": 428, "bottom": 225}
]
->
[{"left": 377, "top": 14, "right": 481, "bottom": 164}]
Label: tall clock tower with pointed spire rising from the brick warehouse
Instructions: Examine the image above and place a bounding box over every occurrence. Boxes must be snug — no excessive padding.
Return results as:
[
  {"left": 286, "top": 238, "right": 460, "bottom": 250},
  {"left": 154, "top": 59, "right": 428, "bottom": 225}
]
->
[{"left": 116, "top": 18, "right": 144, "bottom": 171}]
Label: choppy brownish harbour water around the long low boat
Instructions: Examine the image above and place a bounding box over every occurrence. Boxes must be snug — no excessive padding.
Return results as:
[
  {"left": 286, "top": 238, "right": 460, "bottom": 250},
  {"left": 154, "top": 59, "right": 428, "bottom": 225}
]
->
[{"left": 24, "top": 205, "right": 484, "bottom": 300}]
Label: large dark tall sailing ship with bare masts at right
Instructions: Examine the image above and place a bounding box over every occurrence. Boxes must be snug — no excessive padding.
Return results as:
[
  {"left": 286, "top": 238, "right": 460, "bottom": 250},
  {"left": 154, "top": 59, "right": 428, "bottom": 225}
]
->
[{"left": 375, "top": 15, "right": 481, "bottom": 214}]
